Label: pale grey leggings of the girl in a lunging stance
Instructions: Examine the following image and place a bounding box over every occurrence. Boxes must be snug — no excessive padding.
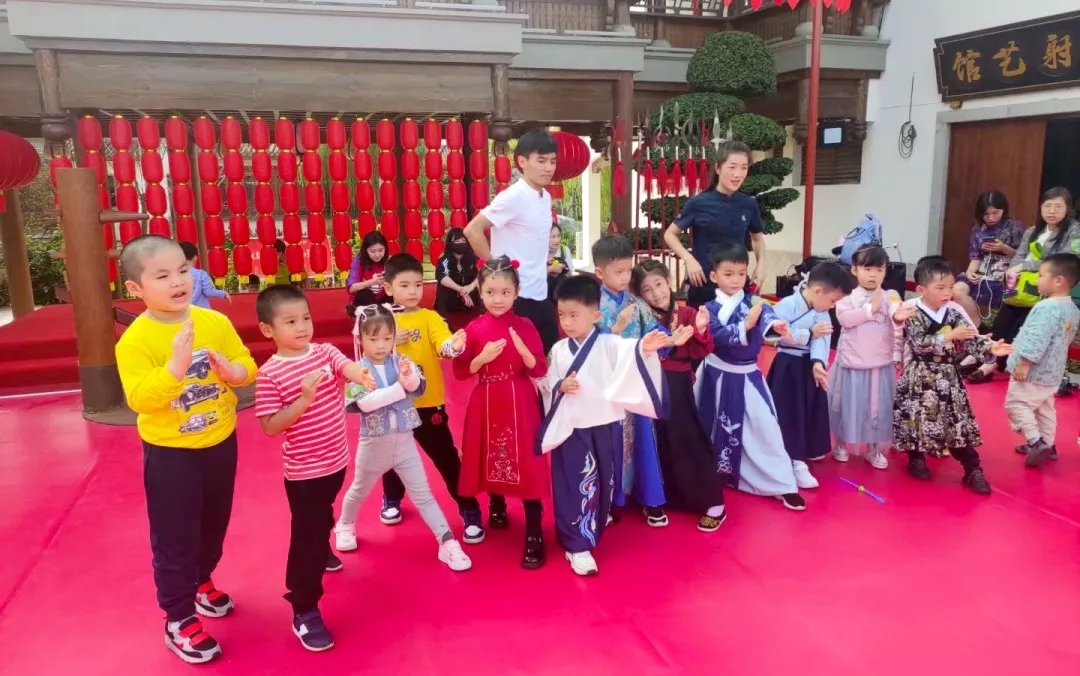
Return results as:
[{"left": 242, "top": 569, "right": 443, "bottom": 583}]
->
[{"left": 341, "top": 432, "right": 450, "bottom": 542}]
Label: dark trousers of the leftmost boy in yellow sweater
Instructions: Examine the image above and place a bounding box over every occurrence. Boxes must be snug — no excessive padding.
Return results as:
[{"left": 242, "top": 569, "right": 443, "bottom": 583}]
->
[{"left": 143, "top": 432, "right": 236, "bottom": 622}]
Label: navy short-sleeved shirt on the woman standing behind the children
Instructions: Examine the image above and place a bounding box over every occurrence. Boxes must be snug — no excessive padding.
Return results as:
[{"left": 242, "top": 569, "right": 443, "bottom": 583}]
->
[{"left": 675, "top": 190, "right": 761, "bottom": 269}]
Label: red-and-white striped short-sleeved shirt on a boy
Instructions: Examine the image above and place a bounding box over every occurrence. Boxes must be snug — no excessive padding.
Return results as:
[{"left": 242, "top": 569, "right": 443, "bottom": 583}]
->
[{"left": 255, "top": 343, "right": 352, "bottom": 481}]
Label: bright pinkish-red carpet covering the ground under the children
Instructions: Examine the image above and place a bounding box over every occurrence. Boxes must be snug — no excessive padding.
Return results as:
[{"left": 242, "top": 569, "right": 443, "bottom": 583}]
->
[{"left": 0, "top": 362, "right": 1080, "bottom": 676}]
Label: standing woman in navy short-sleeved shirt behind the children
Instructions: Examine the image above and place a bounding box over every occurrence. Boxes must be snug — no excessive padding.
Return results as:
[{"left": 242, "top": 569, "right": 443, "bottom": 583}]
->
[{"left": 664, "top": 140, "right": 766, "bottom": 308}]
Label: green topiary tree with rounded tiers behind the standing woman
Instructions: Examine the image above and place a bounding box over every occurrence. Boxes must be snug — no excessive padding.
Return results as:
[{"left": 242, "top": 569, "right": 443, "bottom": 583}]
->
[{"left": 642, "top": 30, "right": 799, "bottom": 233}]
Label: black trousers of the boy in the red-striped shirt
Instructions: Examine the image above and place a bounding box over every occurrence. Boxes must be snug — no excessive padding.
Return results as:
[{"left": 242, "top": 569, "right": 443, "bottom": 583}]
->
[{"left": 285, "top": 468, "right": 345, "bottom": 614}]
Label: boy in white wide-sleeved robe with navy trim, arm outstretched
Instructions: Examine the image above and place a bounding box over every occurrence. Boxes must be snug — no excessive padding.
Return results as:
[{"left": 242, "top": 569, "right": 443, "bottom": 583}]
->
[{"left": 539, "top": 276, "right": 669, "bottom": 576}]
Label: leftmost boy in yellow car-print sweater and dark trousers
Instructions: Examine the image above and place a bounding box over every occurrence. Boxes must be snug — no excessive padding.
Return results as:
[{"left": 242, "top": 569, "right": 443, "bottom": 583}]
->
[{"left": 117, "top": 234, "right": 257, "bottom": 664}]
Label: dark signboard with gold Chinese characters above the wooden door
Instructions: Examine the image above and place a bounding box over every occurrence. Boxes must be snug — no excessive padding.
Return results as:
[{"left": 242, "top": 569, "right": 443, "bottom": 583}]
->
[{"left": 934, "top": 12, "right": 1080, "bottom": 102}]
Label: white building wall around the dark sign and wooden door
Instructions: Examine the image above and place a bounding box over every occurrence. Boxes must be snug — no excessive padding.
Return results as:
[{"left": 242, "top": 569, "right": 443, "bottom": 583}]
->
[{"left": 770, "top": 0, "right": 1080, "bottom": 262}]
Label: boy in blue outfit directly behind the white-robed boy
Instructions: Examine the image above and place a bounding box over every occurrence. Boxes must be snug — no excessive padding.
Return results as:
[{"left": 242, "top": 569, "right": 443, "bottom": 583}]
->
[{"left": 593, "top": 235, "right": 667, "bottom": 528}]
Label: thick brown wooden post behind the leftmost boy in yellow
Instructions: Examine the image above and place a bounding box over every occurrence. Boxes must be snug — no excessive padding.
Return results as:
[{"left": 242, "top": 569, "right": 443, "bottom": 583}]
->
[{"left": 56, "top": 168, "right": 124, "bottom": 418}]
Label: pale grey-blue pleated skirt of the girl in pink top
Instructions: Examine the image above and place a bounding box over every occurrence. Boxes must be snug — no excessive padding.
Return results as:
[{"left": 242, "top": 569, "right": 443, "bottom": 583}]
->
[{"left": 828, "top": 361, "right": 896, "bottom": 444}]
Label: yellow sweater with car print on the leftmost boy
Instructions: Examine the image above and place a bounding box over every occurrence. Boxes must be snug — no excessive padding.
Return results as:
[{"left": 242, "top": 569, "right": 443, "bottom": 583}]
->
[{"left": 117, "top": 307, "right": 257, "bottom": 448}]
